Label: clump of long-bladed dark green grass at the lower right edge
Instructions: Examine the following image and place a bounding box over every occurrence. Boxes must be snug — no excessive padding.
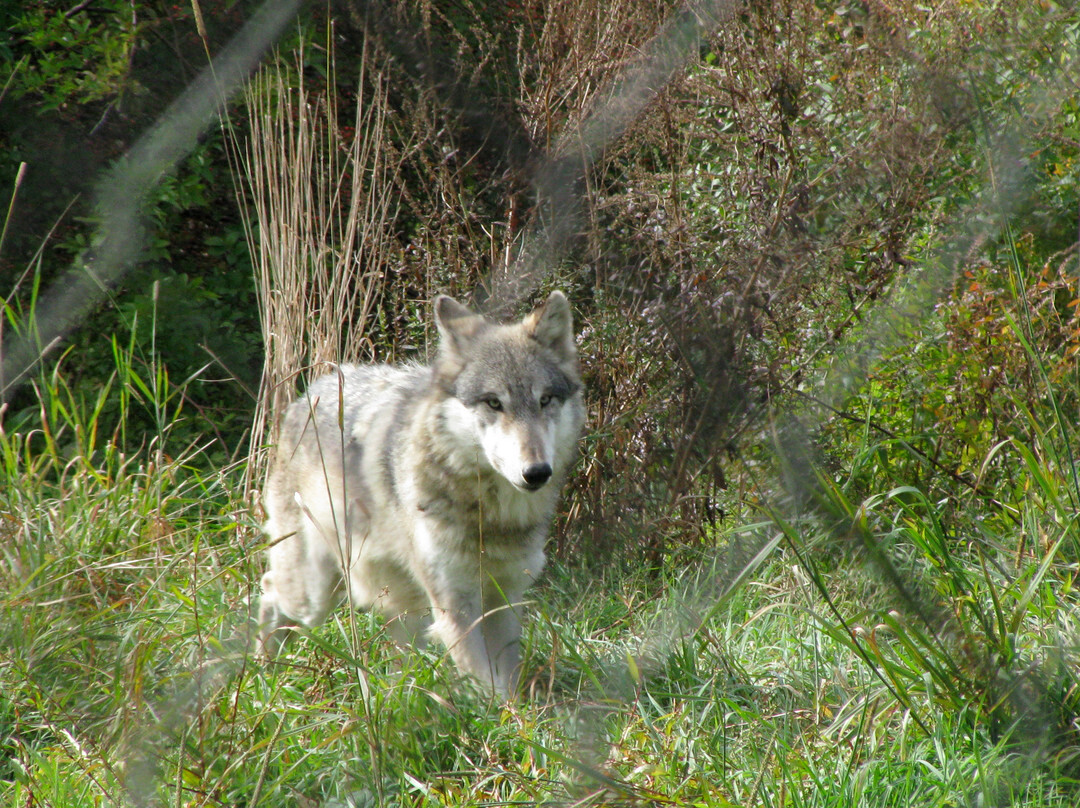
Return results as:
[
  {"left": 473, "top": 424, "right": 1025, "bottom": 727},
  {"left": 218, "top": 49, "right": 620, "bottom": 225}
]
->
[{"left": 768, "top": 214, "right": 1080, "bottom": 782}]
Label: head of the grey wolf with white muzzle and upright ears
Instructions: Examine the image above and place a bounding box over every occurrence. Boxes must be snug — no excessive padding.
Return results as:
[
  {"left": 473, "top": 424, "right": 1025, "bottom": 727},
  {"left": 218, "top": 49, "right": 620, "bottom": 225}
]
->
[{"left": 435, "top": 292, "right": 584, "bottom": 490}]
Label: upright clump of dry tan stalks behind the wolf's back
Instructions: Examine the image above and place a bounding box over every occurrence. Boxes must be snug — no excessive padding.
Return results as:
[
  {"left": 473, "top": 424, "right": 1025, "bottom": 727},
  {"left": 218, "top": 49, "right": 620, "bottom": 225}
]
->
[{"left": 241, "top": 41, "right": 401, "bottom": 488}]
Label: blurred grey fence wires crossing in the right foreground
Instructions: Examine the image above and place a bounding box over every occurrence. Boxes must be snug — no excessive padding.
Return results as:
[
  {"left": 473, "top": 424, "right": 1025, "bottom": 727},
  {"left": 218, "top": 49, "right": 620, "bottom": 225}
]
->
[{"left": 613, "top": 36, "right": 1076, "bottom": 777}]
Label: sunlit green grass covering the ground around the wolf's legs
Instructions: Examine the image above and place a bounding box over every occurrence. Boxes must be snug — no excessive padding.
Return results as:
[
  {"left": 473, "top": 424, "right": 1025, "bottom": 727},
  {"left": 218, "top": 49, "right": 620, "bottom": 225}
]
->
[{"left": 0, "top": 324, "right": 1080, "bottom": 806}]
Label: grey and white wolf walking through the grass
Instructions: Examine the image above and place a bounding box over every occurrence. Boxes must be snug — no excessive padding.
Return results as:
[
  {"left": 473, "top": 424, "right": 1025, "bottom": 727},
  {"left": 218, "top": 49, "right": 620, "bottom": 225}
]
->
[{"left": 259, "top": 292, "right": 584, "bottom": 697}]
